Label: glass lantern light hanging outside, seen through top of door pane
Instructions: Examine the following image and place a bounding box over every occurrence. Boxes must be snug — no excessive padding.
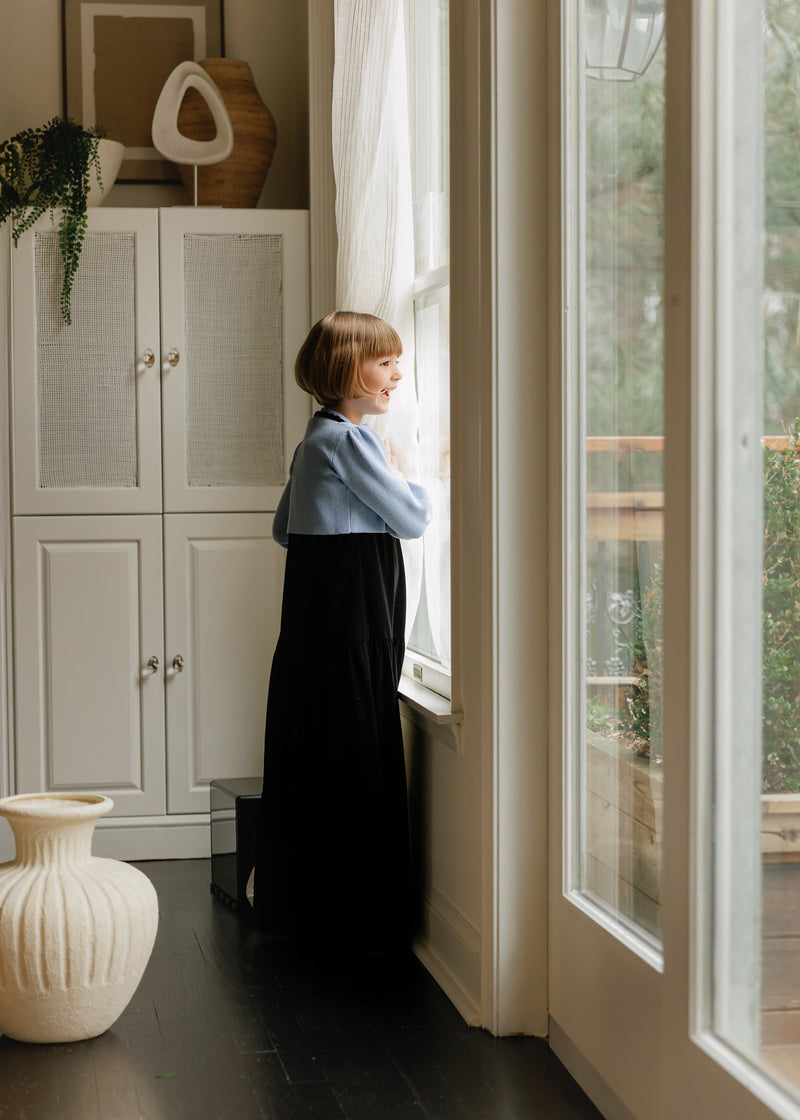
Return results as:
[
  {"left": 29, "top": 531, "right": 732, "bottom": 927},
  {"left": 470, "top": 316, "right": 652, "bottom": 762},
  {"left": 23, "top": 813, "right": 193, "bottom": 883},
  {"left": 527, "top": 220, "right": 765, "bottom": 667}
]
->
[{"left": 584, "top": 0, "right": 666, "bottom": 82}]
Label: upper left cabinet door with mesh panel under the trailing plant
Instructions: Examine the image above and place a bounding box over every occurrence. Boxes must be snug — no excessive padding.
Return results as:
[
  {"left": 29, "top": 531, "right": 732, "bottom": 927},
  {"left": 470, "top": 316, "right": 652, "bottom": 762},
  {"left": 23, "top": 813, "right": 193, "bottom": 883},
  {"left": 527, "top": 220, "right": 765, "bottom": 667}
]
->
[{"left": 11, "top": 208, "right": 161, "bottom": 514}]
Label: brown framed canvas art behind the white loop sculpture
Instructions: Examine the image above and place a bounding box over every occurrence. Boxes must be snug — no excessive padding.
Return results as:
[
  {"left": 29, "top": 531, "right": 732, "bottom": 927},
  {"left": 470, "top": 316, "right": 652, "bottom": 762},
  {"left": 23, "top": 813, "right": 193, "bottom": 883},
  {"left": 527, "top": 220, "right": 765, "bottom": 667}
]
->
[{"left": 63, "top": 0, "right": 223, "bottom": 183}]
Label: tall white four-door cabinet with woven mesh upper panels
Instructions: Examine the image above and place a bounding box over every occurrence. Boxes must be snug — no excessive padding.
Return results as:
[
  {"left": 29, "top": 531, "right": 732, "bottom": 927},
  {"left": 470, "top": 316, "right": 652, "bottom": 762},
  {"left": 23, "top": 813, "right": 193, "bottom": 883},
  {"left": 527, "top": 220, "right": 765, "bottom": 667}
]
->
[{"left": 11, "top": 207, "right": 308, "bottom": 858}]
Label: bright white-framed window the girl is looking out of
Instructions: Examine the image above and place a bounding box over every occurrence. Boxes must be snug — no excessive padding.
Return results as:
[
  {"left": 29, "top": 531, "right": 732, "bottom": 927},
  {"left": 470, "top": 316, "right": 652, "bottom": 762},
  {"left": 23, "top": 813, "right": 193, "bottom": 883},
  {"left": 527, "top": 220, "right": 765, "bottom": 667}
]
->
[{"left": 404, "top": 0, "right": 450, "bottom": 697}]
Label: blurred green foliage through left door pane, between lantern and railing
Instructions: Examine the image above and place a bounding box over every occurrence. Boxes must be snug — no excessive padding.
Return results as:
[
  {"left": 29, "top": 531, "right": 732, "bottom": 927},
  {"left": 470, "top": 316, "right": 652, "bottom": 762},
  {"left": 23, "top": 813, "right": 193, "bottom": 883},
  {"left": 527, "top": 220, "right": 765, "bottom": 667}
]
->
[{"left": 585, "top": 32, "right": 666, "bottom": 443}]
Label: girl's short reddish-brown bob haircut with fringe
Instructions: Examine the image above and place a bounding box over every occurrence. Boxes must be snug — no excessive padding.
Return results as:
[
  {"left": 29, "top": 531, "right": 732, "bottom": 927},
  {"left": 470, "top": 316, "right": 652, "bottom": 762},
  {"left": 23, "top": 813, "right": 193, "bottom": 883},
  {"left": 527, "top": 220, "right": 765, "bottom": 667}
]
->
[{"left": 295, "top": 311, "right": 402, "bottom": 409}]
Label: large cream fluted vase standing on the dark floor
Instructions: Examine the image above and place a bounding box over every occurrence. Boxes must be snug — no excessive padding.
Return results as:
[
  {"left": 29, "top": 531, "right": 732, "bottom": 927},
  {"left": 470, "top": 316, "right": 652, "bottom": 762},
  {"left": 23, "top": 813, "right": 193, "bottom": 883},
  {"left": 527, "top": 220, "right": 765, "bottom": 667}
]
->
[{"left": 0, "top": 793, "right": 158, "bottom": 1043}]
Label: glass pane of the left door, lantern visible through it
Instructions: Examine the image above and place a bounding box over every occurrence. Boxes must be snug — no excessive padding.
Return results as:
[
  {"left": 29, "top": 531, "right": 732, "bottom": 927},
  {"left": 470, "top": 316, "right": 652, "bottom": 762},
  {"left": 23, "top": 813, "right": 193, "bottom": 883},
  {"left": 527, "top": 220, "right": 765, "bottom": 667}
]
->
[{"left": 570, "top": 0, "right": 666, "bottom": 944}]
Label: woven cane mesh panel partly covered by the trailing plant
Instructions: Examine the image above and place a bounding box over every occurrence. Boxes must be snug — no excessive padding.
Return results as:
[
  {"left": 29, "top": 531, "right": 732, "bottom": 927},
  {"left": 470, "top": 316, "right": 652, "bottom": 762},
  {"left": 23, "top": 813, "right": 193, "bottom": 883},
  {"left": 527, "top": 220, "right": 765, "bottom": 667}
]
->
[{"left": 35, "top": 231, "right": 138, "bottom": 489}]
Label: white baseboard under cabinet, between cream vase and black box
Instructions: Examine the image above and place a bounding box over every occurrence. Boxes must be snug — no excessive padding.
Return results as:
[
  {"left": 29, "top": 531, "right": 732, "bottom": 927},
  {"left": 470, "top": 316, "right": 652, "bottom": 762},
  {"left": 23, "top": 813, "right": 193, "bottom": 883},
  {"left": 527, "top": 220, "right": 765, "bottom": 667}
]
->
[{"left": 92, "top": 813, "right": 211, "bottom": 860}]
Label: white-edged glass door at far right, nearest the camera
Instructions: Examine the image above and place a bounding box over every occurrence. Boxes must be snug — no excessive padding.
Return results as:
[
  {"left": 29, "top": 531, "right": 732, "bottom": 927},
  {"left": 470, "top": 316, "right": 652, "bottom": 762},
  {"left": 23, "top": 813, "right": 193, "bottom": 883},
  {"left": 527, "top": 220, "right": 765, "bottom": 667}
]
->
[{"left": 672, "top": 0, "right": 800, "bottom": 1118}]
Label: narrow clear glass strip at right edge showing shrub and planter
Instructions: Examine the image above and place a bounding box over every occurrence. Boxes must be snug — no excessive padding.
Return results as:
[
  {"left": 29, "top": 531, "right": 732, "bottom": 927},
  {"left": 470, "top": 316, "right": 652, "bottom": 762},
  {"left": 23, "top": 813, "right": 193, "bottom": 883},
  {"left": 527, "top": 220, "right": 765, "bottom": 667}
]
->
[{"left": 761, "top": 0, "right": 800, "bottom": 1086}]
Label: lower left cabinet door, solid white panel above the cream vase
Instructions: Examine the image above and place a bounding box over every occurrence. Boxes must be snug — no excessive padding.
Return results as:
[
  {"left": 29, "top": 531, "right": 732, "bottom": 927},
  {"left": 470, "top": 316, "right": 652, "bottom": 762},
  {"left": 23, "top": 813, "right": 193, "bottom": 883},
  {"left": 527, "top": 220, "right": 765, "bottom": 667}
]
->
[{"left": 13, "top": 515, "right": 165, "bottom": 815}]
